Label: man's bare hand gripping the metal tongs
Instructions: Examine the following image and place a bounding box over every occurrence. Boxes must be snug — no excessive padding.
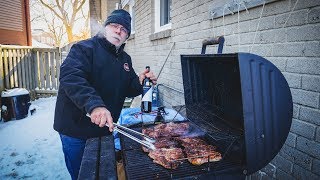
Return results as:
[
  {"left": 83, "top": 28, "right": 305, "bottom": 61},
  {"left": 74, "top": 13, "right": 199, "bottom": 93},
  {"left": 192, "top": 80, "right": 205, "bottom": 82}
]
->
[{"left": 90, "top": 107, "right": 114, "bottom": 132}]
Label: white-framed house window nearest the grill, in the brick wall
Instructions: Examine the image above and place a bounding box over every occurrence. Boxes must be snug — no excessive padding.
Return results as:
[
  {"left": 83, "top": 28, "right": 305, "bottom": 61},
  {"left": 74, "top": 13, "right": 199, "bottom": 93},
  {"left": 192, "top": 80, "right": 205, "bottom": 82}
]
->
[{"left": 154, "top": 0, "right": 171, "bottom": 32}]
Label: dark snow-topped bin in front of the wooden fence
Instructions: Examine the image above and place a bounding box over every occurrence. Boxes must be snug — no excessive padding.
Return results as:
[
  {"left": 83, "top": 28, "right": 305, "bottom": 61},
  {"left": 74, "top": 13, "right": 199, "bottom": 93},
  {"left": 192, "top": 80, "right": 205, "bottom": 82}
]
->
[{"left": 1, "top": 88, "right": 30, "bottom": 122}]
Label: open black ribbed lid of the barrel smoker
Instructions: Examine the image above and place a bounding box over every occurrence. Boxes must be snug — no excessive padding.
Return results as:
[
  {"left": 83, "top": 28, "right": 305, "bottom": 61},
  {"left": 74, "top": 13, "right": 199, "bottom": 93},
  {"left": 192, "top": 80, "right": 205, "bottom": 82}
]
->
[{"left": 181, "top": 53, "right": 293, "bottom": 174}]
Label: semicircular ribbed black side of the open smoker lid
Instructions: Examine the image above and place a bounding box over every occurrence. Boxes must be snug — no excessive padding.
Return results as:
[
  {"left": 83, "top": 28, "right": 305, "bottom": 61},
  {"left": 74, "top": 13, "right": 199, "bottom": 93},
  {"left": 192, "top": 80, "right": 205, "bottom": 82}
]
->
[{"left": 238, "top": 53, "right": 293, "bottom": 173}]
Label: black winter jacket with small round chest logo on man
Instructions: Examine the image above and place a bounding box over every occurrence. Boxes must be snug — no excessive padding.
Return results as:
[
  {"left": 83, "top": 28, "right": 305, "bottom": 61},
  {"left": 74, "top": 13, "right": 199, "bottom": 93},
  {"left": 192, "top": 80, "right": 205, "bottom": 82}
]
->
[{"left": 53, "top": 35, "right": 142, "bottom": 139}]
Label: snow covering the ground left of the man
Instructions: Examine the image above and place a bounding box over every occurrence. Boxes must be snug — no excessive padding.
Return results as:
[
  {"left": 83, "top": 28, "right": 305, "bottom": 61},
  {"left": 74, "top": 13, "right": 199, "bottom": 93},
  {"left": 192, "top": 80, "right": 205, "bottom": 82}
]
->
[{"left": 0, "top": 97, "right": 71, "bottom": 180}]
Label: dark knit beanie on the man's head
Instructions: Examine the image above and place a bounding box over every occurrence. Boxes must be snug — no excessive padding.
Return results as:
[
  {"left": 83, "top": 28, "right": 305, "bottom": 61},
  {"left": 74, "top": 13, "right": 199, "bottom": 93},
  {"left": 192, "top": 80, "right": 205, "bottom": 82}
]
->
[{"left": 104, "top": 9, "right": 131, "bottom": 37}]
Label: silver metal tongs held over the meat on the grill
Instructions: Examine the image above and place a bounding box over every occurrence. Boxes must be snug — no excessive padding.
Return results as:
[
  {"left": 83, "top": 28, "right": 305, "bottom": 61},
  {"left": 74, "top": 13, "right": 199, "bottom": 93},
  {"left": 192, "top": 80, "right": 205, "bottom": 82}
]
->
[{"left": 86, "top": 114, "right": 156, "bottom": 150}]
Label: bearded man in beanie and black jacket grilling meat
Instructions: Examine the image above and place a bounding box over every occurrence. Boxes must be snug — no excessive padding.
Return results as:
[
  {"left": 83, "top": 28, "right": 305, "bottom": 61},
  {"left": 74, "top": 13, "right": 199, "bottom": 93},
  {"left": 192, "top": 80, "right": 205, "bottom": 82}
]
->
[{"left": 54, "top": 9, "right": 156, "bottom": 179}]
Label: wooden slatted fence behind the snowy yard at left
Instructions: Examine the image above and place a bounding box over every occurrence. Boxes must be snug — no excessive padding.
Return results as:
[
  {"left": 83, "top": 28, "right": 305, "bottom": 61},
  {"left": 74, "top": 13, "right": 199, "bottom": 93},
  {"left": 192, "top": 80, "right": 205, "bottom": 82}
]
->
[{"left": 0, "top": 45, "right": 61, "bottom": 94}]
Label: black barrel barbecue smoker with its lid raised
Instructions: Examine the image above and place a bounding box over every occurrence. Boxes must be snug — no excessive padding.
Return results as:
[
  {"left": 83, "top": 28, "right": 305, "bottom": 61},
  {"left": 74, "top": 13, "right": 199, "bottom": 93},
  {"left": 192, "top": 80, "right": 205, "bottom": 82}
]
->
[{"left": 78, "top": 37, "right": 293, "bottom": 179}]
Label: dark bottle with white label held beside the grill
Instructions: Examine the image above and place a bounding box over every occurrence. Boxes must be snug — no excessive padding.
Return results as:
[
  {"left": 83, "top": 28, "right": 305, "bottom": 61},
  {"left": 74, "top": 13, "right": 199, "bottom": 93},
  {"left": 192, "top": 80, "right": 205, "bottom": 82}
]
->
[{"left": 141, "top": 66, "right": 152, "bottom": 113}]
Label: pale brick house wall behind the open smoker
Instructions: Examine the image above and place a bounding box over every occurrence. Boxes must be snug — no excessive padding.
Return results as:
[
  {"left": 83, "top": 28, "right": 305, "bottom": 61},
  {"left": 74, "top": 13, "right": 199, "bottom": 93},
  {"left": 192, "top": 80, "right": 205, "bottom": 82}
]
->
[{"left": 126, "top": 0, "right": 320, "bottom": 179}]
